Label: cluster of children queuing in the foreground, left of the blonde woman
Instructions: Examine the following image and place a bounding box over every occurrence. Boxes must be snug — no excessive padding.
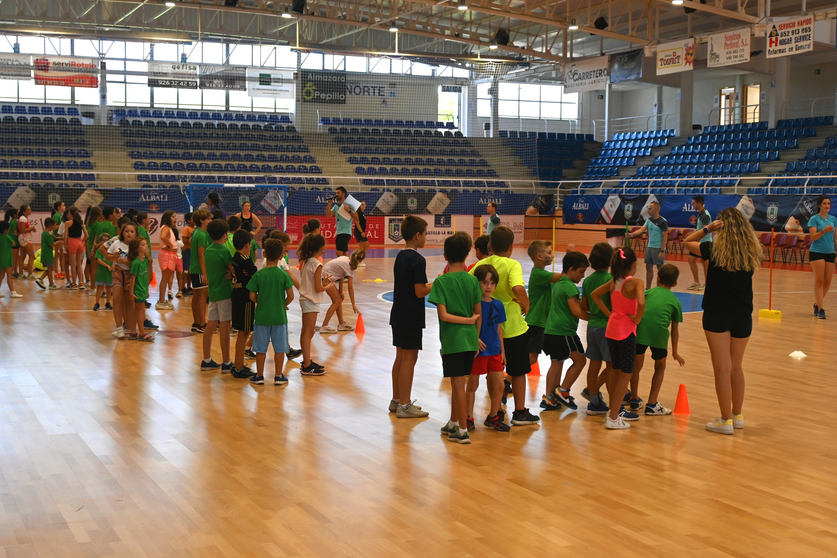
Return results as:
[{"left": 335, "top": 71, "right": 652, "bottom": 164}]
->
[{"left": 389, "top": 221, "right": 684, "bottom": 444}]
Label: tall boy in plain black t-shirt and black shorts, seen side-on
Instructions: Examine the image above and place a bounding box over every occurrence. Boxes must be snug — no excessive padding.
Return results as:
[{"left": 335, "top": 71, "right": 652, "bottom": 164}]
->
[{"left": 389, "top": 215, "right": 433, "bottom": 418}]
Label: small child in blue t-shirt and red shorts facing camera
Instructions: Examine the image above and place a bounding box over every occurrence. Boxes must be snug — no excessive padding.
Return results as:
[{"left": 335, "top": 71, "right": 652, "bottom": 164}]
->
[{"left": 468, "top": 264, "right": 511, "bottom": 432}]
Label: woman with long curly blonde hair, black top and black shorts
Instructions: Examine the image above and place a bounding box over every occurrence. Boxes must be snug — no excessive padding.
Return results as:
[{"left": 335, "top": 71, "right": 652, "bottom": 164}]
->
[{"left": 686, "top": 207, "right": 762, "bottom": 434}]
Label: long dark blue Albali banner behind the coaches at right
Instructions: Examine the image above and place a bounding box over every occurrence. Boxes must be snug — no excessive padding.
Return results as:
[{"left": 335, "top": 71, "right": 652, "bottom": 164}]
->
[{"left": 564, "top": 194, "right": 817, "bottom": 235}]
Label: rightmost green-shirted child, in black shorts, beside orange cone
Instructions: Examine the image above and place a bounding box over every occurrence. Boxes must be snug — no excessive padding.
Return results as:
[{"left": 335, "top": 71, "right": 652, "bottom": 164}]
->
[{"left": 629, "top": 264, "right": 686, "bottom": 416}]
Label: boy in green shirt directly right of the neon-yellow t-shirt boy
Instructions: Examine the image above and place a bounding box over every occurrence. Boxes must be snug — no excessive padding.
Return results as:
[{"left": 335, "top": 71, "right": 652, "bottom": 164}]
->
[{"left": 526, "top": 240, "right": 561, "bottom": 364}]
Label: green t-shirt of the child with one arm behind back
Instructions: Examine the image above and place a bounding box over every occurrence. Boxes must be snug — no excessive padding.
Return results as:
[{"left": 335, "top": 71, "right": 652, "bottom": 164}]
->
[{"left": 428, "top": 271, "right": 480, "bottom": 355}]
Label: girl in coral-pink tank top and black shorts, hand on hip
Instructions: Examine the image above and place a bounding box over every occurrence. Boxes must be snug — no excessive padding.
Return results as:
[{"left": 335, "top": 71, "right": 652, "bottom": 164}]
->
[{"left": 590, "top": 247, "right": 645, "bottom": 430}]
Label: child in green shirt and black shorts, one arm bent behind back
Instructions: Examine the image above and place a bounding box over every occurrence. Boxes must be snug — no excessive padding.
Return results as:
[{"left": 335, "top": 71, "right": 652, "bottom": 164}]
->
[{"left": 428, "top": 232, "right": 482, "bottom": 444}]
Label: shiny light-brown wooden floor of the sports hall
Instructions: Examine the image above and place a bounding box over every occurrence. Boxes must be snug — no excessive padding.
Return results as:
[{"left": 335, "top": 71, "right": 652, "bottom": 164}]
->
[{"left": 0, "top": 248, "right": 837, "bottom": 558}]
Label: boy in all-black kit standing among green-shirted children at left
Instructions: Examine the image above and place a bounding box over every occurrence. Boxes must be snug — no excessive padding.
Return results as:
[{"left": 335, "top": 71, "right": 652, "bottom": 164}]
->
[{"left": 230, "top": 230, "right": 258, "bottom": 378}]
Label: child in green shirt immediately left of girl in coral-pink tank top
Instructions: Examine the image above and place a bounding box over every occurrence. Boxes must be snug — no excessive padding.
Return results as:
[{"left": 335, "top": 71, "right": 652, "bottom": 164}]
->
[{"left": 581, "top": 242, "right": 613, "bottom": 415}]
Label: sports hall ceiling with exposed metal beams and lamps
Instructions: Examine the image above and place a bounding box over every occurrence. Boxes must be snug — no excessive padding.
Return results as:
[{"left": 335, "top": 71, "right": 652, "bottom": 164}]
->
[{"left": 0, "top": 0, "right": 835, "bottom": 63}]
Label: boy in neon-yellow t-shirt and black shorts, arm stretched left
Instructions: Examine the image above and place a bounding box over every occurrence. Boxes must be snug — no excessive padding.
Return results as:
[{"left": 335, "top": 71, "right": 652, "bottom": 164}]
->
[{"left": 469, "top": 225, "right": 540, "bottom": 426}]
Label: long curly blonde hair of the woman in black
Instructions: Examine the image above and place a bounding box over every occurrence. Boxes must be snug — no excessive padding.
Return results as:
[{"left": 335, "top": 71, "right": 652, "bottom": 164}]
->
[{"left": 712, "top": 207, "right": 763, "bottom": 271}]
